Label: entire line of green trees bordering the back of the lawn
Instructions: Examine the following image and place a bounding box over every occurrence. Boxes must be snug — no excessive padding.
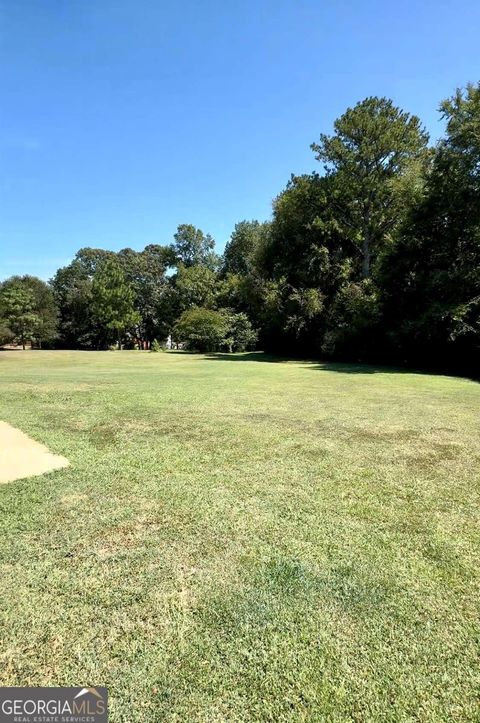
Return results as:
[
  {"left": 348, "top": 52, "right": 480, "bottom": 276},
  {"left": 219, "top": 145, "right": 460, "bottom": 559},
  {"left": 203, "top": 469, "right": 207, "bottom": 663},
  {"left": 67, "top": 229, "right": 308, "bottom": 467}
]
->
[{"left": 0, "top": 83, "right": 480, "bottom": 373}]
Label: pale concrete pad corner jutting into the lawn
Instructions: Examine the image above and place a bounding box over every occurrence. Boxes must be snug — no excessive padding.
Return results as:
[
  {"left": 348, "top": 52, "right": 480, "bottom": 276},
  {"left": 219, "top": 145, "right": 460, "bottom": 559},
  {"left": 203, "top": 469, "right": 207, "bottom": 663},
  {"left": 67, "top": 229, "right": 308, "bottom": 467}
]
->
[{"left": 0, "top": 421, "right": 70, "bottom": 484}]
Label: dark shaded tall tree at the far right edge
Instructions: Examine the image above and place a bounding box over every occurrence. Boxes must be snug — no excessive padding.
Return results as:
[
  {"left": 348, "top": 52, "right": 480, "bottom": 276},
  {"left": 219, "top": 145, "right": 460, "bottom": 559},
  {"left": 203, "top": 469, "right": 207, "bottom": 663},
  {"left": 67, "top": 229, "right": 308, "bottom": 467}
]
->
[{"left": 380, "top": 84, "right": 480, "bottom": 373}]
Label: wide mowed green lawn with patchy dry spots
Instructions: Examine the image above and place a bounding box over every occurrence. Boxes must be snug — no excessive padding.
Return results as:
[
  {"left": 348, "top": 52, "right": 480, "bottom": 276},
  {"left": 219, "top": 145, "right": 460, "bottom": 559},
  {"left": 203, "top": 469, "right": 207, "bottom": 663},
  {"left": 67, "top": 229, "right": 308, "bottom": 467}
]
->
[{"left": 0, "top": 352, "right": 480, "bottom": 723}]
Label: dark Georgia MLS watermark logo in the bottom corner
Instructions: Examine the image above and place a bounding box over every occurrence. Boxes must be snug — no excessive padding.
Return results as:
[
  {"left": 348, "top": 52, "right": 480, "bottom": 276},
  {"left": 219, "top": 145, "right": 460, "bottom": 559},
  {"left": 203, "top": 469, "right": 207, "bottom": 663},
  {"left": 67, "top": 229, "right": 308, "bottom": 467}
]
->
[{"left": 0, "top": 688, "right": 108, "bottom": 723}]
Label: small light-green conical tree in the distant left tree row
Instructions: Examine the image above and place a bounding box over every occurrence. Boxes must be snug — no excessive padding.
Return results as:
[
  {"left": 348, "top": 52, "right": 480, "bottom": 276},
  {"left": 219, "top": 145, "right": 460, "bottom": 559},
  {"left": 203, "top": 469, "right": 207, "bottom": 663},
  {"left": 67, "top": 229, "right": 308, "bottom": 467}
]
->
[{"left": 91, "top": 258, "right": 140, "bottom": 349}]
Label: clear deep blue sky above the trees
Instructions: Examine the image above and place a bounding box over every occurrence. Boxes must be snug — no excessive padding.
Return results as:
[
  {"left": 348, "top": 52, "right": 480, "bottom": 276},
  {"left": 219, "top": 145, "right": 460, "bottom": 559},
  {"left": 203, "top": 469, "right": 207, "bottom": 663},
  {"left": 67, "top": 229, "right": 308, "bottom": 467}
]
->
[{"left": 0, "top": 0, "right": 480, "bottom": 279}]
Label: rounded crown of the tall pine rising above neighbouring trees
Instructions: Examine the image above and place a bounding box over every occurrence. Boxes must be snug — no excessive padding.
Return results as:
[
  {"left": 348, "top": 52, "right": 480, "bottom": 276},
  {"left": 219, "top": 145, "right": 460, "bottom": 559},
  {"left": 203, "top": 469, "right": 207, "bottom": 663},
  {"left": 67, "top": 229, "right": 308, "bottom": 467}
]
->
[{"left": 312, "top": 97, "right": 428, "bottom": 278}]
